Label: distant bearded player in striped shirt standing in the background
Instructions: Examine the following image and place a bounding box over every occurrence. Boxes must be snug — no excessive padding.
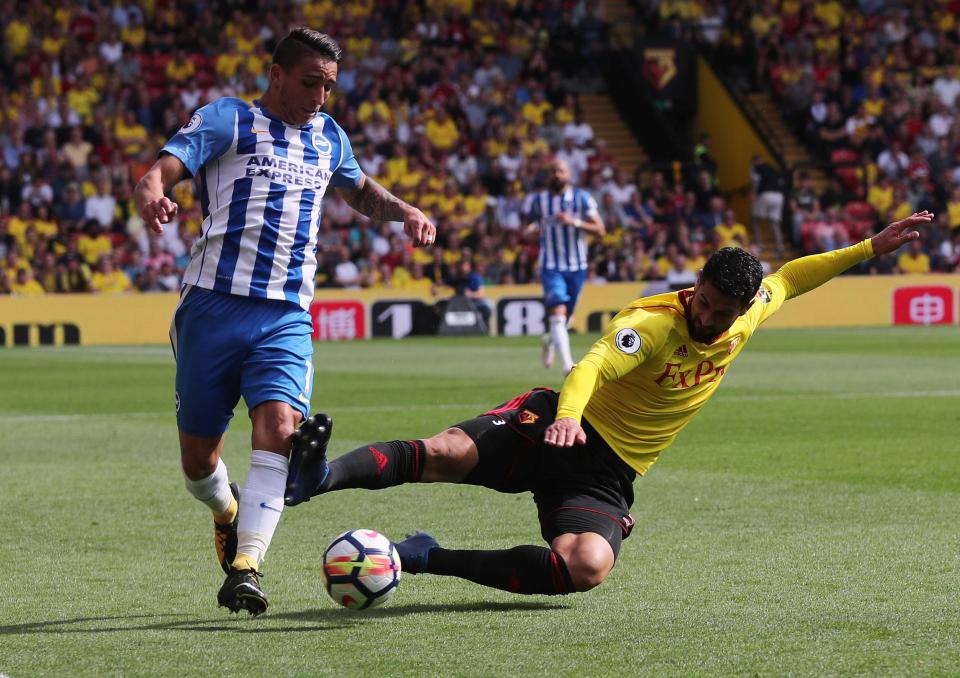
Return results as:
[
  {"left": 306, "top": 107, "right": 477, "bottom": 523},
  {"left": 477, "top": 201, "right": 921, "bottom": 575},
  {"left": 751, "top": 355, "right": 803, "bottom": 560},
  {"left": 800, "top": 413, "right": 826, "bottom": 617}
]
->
[{"left": 526, "top": 159, "right": 606, "bottom": 374}]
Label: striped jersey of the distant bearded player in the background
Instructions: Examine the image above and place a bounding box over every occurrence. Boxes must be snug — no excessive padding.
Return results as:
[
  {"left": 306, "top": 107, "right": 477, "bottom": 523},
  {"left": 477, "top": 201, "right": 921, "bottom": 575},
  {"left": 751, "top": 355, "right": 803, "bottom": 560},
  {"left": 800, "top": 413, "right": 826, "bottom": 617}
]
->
[{"left": 527, "top": 188, "right": 599, "bottom": 271}]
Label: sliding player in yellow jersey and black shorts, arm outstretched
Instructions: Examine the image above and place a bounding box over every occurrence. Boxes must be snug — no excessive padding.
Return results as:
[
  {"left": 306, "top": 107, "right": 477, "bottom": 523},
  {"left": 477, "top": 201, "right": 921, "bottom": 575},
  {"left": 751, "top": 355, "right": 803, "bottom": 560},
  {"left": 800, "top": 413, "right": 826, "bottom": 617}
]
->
[{"left": 284, "top": 212, "right": 933, "bottom": 595}]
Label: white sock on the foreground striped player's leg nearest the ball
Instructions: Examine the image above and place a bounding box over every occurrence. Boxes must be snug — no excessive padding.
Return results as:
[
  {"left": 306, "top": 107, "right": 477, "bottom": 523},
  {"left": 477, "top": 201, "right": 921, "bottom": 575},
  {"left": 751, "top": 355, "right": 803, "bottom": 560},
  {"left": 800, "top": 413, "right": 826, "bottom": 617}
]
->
[{"left": 237, "top": 450, "right": 290, "bottom": 565}]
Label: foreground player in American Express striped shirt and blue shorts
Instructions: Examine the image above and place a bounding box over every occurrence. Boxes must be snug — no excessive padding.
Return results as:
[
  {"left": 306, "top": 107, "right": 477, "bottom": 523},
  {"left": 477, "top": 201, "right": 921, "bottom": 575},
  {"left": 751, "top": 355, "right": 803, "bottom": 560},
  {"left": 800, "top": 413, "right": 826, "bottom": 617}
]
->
[{"left": 136, "top": 27, "right": 436, "bottom": 614}]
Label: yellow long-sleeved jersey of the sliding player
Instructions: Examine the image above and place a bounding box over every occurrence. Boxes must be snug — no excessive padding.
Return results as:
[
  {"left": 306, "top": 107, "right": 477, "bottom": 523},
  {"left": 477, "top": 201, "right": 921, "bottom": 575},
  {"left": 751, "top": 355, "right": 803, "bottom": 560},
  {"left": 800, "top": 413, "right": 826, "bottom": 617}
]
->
[{"left": 557, "top": 240, "right": 873, "bottom": 475}]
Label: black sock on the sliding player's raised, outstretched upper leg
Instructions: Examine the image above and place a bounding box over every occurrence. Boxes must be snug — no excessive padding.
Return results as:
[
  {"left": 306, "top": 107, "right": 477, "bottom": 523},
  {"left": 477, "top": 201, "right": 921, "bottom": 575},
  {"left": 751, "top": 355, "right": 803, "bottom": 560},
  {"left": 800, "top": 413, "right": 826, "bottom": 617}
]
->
[{"left": 320, "top": 440, "right": 426, "bottom": 492}]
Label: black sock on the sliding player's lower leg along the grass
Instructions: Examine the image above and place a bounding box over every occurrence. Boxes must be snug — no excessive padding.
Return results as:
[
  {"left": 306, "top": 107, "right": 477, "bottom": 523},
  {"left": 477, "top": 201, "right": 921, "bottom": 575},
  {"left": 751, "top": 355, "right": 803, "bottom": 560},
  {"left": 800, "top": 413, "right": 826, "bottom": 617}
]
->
[{"left": 426, "top": 546, "right": 575, "bottom": 596}]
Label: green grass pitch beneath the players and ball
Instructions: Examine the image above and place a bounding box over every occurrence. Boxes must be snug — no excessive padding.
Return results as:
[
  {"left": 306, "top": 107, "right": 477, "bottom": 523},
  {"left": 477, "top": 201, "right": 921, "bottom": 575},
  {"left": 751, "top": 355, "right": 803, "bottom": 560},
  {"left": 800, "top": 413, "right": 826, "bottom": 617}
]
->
[{"left": 0, "top": 328, "right": 960, "bottom": 678}]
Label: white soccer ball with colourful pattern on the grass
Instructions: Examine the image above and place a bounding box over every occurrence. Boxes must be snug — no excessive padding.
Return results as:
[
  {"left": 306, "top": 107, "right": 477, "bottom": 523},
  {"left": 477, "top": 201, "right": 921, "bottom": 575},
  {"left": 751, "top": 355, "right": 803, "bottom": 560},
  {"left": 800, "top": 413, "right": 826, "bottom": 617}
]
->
[{"left": 323, "top": 530, "right": 400, "bottom": 610}]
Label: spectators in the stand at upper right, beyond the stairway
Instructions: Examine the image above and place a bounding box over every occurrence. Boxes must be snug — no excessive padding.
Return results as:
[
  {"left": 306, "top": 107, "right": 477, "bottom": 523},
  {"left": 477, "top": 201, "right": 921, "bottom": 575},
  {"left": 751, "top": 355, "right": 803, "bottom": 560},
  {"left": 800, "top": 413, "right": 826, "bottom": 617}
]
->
[{"left": 645, "top": 0, "right": 960, "bottom": 273}]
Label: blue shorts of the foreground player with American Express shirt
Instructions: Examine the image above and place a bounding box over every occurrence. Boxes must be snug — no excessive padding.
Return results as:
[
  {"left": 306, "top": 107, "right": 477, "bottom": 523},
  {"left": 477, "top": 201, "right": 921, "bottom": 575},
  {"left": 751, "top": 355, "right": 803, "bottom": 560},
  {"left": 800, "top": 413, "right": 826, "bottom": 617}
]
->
[{"left": 170, "top": 287, "right": 313, "bottom": 437}]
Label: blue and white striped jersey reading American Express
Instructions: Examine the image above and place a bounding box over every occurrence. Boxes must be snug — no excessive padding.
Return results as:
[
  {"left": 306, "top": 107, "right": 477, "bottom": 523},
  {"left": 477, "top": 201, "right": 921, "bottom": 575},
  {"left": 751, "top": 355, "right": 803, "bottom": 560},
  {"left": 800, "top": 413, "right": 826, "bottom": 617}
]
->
[{"left": 160, "top": 97, "right": 362, "bottom": 309}]
